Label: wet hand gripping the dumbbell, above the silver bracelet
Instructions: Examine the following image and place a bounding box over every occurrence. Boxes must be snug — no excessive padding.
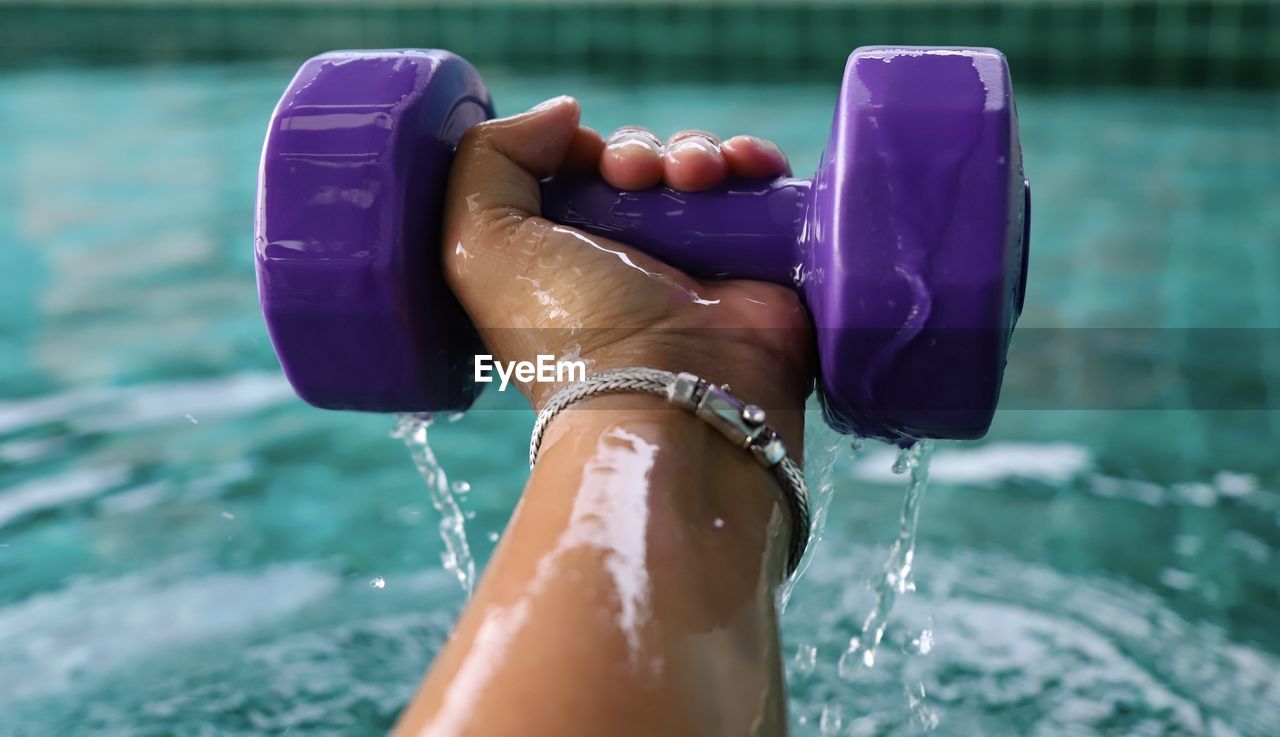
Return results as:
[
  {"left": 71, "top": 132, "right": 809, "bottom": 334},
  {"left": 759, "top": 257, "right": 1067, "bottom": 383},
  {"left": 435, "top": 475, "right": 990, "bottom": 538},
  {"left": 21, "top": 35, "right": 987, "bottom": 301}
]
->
[{"left": 444, "top": 97, "right": 813, "bottom": 436}]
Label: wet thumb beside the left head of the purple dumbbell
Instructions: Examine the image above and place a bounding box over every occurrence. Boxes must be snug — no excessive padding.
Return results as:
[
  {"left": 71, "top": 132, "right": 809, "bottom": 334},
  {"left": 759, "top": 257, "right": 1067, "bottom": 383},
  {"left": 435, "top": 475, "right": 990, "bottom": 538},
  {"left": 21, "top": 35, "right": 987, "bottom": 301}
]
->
[{"left": 445, "top": 97, "right": 581, "bottom": 230}]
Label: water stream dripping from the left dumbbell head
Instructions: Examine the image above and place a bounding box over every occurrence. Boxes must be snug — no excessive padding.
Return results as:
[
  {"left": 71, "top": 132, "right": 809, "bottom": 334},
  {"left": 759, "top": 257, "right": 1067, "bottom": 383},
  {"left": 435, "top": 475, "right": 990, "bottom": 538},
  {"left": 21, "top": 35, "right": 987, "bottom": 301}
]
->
[{"left": 392, "top": 413, "right": 476, "bottom": 598}]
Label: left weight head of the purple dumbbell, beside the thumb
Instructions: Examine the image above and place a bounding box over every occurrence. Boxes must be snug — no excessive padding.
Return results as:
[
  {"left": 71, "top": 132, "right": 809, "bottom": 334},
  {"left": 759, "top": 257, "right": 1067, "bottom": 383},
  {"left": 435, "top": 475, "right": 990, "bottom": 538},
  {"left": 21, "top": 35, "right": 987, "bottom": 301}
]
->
[{"left": 255, "top": 50, "right": 493, "bottom": 412}]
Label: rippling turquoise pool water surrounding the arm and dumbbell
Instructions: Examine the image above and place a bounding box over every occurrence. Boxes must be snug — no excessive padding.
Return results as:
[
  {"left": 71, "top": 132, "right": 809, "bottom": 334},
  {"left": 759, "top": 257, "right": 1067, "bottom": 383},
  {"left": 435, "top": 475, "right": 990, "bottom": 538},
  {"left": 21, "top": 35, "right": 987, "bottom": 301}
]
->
[{"left": 0, "top": 67, "right": 1280, "bottom": 737}]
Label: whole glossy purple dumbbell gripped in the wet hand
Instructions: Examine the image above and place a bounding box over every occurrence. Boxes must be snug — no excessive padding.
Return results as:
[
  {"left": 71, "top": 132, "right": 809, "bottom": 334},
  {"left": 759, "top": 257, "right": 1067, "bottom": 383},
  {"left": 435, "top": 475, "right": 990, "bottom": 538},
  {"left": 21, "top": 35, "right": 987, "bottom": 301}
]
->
[{"left": 255, "top": 46, "right": 1030, "bottom": 441}]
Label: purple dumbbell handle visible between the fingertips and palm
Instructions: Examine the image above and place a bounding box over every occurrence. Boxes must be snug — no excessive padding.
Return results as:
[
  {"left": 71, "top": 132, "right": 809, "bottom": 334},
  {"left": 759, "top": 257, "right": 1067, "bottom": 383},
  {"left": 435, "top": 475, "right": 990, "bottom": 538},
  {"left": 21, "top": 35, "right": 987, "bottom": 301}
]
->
[{"left": 541, "top": 175, "right": 809, "bottom": 287}]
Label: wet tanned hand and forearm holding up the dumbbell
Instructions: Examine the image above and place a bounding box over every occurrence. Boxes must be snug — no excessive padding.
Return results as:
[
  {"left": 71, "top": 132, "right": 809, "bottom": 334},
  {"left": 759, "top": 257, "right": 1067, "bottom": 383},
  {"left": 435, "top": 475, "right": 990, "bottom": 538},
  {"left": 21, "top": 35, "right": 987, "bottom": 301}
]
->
[{"left": 394, "top": 99, "right": 813, "bottom": 737}]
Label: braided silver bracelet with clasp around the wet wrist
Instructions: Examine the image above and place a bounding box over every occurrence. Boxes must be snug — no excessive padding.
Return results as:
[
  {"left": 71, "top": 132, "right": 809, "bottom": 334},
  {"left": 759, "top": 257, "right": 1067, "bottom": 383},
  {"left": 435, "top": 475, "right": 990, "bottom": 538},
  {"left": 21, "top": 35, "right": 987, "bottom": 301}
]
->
[{"left": 529, "top": 367, "right": 809, "bottom": 576}]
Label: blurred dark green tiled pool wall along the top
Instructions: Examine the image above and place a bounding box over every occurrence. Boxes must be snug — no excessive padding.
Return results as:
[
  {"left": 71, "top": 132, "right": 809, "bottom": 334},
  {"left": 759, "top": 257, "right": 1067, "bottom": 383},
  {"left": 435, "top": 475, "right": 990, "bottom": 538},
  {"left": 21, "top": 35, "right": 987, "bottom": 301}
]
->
[{"left": 0, "top": 0, "right": 1280, "bottom": 90}]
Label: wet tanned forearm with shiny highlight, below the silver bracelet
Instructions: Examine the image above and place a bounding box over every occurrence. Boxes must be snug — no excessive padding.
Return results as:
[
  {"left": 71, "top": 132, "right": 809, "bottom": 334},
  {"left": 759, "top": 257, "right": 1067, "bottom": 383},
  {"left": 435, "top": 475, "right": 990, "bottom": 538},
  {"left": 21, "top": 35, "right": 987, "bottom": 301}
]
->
[{"left": 397, "top": 388, "right": 803, "bottom": 737}]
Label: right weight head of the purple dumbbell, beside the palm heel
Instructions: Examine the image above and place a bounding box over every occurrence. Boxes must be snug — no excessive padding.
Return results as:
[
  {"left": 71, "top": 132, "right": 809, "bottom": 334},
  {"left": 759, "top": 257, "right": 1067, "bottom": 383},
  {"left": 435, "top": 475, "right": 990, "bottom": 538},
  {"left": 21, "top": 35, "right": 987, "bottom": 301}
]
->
[{"left": 804, "top": 47, "right": 1029, "bottom": 439}]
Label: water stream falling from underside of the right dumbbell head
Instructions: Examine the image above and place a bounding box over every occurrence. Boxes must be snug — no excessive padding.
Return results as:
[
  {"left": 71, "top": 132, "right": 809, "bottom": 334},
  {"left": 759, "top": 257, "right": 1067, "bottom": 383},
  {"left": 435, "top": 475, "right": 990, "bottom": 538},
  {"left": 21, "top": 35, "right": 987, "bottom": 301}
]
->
[{"left": 837, "top": 440, "right": 933, "bottom": 681}]
